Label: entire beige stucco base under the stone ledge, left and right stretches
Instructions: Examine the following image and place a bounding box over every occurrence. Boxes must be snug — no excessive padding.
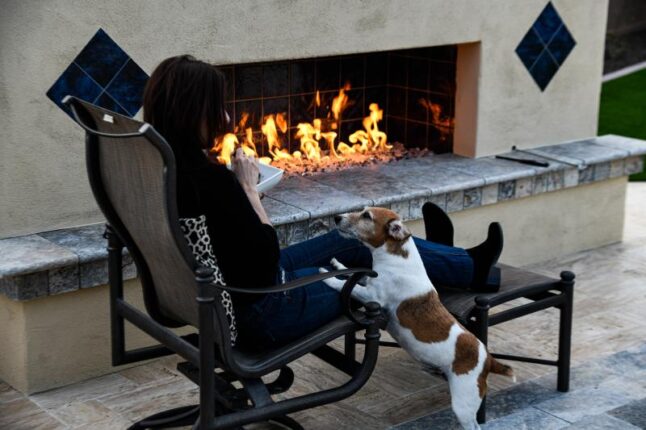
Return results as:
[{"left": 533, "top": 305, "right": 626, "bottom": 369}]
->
[{"left": 0, "top": 178, "right": 626, "bottom": 393}]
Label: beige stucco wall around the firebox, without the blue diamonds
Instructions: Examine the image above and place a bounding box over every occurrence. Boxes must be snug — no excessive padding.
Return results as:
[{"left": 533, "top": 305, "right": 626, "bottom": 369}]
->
[{"left": 0, "top": 0, "right": 607, "bottom": 237}]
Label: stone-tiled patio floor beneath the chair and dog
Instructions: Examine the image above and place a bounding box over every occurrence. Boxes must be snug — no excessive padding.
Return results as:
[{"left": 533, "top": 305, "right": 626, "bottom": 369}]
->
[{"left": 0, "top": 183, "right": 646, "bottom": 430}]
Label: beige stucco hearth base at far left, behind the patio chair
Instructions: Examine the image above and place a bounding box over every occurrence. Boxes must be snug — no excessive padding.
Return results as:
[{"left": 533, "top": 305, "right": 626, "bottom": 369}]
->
[{"left": 0, "top": 280, "right": 197, "bottom": 394}]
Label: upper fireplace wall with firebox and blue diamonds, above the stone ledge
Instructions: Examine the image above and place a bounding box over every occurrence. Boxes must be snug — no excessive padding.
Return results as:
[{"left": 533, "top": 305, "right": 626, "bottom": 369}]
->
[{"left": 0, "top": 0, "right": 607, "bottom": 237}]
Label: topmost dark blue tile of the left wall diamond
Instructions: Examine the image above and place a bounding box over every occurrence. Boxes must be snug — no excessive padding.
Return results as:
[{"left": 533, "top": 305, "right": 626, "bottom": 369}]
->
[{"left": 74, "top": 29, "right": 129, "bottom": 87}]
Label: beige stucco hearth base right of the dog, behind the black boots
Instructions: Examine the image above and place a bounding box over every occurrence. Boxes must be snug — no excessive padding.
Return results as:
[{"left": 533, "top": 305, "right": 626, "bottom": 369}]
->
[{"left": 409, "top": 177, "right": 626, "bottom": 266}]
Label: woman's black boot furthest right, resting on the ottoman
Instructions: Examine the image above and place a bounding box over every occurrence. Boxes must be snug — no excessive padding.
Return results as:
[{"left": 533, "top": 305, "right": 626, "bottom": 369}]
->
[{"left": 466, "top": 222, "right": 503, "bottom": 292}]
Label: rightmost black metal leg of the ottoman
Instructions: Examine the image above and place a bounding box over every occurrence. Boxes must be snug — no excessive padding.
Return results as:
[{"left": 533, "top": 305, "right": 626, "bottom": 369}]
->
[{"left": 556, "top": 271, "right": 574, "bottom": 392}]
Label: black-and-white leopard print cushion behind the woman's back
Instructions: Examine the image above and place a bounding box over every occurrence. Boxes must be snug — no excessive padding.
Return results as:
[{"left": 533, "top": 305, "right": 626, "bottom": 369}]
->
[{"left": 179, "top": 215, "right": 238, "bottom": 345}]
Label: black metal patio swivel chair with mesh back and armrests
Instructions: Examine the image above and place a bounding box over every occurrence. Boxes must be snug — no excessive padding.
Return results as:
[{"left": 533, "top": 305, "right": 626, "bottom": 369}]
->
[{"left": 64, "top": 96, "right": 381, "bottom": 429}]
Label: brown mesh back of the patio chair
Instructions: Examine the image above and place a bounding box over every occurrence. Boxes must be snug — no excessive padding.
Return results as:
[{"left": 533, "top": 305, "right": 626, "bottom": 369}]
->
[{"left": 79, "top": 103, "right": 198, "bottom": 325}]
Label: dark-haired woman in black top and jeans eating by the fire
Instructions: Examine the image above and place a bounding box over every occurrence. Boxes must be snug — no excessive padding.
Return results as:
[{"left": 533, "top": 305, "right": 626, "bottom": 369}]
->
[{"left": 144, "top": 55, "right": 502, "bottom": 347}]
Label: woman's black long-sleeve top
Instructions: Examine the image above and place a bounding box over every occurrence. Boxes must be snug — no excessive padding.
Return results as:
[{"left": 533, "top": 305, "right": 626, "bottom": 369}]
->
[{"left": 177, "top": 149, "right": 280, "bottom": 302}]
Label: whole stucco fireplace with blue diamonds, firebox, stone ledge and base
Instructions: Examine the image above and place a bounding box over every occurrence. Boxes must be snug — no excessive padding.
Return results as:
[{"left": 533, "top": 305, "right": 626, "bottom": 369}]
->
[{"left": 0, "top": 0, "right": 646, "bottom": 393}]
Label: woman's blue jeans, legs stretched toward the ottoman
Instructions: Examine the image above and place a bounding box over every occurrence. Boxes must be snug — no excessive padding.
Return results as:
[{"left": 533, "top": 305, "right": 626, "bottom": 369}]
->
[{"left": 236, "top": 230, "right": 473, "bottom": 348}]
